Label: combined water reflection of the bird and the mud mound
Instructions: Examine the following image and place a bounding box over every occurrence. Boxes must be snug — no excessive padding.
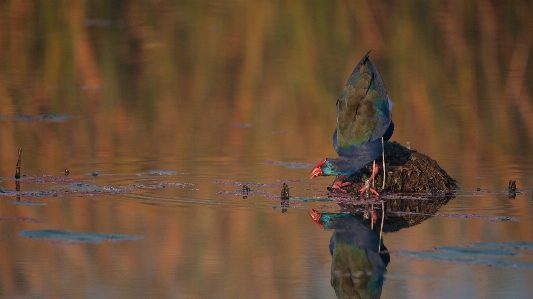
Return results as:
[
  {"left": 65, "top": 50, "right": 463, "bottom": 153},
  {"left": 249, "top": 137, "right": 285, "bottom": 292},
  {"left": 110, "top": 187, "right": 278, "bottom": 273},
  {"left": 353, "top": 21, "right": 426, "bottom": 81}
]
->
[{"left": 308, "top": 192, "right": 455, "bottom": 298}]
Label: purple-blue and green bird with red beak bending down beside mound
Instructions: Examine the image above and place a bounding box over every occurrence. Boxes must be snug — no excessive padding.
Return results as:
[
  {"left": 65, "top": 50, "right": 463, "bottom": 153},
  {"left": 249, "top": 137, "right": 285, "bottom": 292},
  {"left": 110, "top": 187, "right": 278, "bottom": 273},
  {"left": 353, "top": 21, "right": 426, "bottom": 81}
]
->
[{"left": 309, "top": 51, "right": 394, "bottom": 195}]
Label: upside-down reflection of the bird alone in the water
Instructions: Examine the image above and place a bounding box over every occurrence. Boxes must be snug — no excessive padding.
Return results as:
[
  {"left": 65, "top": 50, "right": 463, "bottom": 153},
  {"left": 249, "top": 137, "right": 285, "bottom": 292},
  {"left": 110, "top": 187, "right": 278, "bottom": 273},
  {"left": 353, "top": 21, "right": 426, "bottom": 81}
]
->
[{"left": 309, "top": 209, "right": 390, "bottom": 298}]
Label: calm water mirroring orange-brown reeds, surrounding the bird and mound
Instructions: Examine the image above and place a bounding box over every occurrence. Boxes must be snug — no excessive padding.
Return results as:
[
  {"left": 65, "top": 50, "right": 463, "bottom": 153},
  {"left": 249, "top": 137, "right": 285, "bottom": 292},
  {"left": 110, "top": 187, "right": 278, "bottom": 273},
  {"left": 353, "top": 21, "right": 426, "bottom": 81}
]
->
[{"left": 0, "top": 1, "right": 533, "bottom": 298}]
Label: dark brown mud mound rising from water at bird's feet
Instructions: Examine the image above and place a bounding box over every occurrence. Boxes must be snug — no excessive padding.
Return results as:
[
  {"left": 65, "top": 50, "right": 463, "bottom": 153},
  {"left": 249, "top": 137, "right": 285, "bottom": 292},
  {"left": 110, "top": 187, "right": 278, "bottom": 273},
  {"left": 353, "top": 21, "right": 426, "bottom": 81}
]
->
[{"left": 328, "top": 141, "right": 459, "bottom": 193}]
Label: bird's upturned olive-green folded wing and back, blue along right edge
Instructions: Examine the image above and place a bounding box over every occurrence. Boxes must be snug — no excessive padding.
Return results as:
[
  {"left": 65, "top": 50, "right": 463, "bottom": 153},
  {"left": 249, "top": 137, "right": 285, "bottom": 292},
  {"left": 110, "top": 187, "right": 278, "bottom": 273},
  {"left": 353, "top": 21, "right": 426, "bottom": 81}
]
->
[{"left": 333, "top": 52, "right": 392, "bottom": 156}]
